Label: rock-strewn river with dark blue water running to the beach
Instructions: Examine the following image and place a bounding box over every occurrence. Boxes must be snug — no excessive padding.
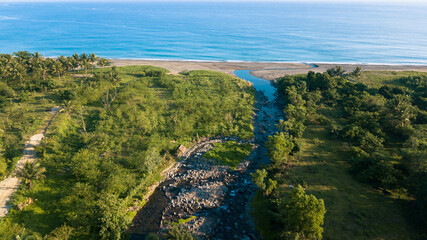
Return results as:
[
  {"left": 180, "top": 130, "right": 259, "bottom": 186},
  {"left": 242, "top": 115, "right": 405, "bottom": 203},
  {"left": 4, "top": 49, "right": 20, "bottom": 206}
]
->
[{"left": 129, "top": 70, "right": 283, "bottom": 239}]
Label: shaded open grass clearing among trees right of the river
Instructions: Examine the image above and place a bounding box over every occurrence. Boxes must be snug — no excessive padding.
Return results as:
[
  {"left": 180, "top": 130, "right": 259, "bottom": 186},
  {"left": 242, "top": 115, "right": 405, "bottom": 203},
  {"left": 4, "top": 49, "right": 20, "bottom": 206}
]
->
[{"left": 281, "top": 125, "right": 413, "bottom": 239}]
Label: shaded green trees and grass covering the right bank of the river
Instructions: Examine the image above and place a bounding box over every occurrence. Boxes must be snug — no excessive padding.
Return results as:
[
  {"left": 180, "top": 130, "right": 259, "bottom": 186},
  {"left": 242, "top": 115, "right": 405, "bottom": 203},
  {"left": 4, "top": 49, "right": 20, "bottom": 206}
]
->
[{"left": 253, "top": 67, "right": 427, "bottom": 239}]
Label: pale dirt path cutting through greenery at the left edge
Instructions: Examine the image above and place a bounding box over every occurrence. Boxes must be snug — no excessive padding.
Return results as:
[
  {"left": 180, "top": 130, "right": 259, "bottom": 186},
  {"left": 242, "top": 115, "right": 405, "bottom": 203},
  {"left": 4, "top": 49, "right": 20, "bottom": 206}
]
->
[{"left": 0, "top": 107, "right": 61, "bottom": 217}]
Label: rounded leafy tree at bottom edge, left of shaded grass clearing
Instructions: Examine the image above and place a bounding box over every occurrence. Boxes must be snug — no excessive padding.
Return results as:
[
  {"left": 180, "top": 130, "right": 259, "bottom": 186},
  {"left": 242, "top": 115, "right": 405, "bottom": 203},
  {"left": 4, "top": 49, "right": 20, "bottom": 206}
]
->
[{"left": 277, "top": 185, "right": 326, "bottom": 239}]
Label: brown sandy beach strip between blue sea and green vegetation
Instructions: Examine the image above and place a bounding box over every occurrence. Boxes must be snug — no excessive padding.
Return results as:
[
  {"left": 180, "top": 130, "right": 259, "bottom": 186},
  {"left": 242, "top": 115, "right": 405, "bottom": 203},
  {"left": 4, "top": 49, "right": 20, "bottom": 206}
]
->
[{"left": 111, "top": 59, "right": 427, "bottom": 80}]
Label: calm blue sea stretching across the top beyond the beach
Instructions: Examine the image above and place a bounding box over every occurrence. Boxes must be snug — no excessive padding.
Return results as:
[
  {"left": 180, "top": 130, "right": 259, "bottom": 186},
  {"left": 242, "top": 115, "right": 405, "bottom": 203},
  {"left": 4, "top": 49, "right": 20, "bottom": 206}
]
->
[{"left": 0, "top": 2, "right": 427, "bottom": 64}]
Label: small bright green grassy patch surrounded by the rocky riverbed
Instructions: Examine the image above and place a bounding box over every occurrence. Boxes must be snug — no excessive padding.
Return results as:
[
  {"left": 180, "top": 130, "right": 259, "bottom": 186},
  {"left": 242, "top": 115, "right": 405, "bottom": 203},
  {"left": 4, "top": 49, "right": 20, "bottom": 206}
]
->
[{"left": 203, "top": 141, "right": 252, "bottom": 169}]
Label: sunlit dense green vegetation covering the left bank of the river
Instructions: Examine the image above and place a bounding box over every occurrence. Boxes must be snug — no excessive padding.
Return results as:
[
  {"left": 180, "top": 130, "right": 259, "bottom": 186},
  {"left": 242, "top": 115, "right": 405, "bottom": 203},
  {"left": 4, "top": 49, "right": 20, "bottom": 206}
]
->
[{"left": 0, "top": 52, "right": 254, "bottom": 239}]
